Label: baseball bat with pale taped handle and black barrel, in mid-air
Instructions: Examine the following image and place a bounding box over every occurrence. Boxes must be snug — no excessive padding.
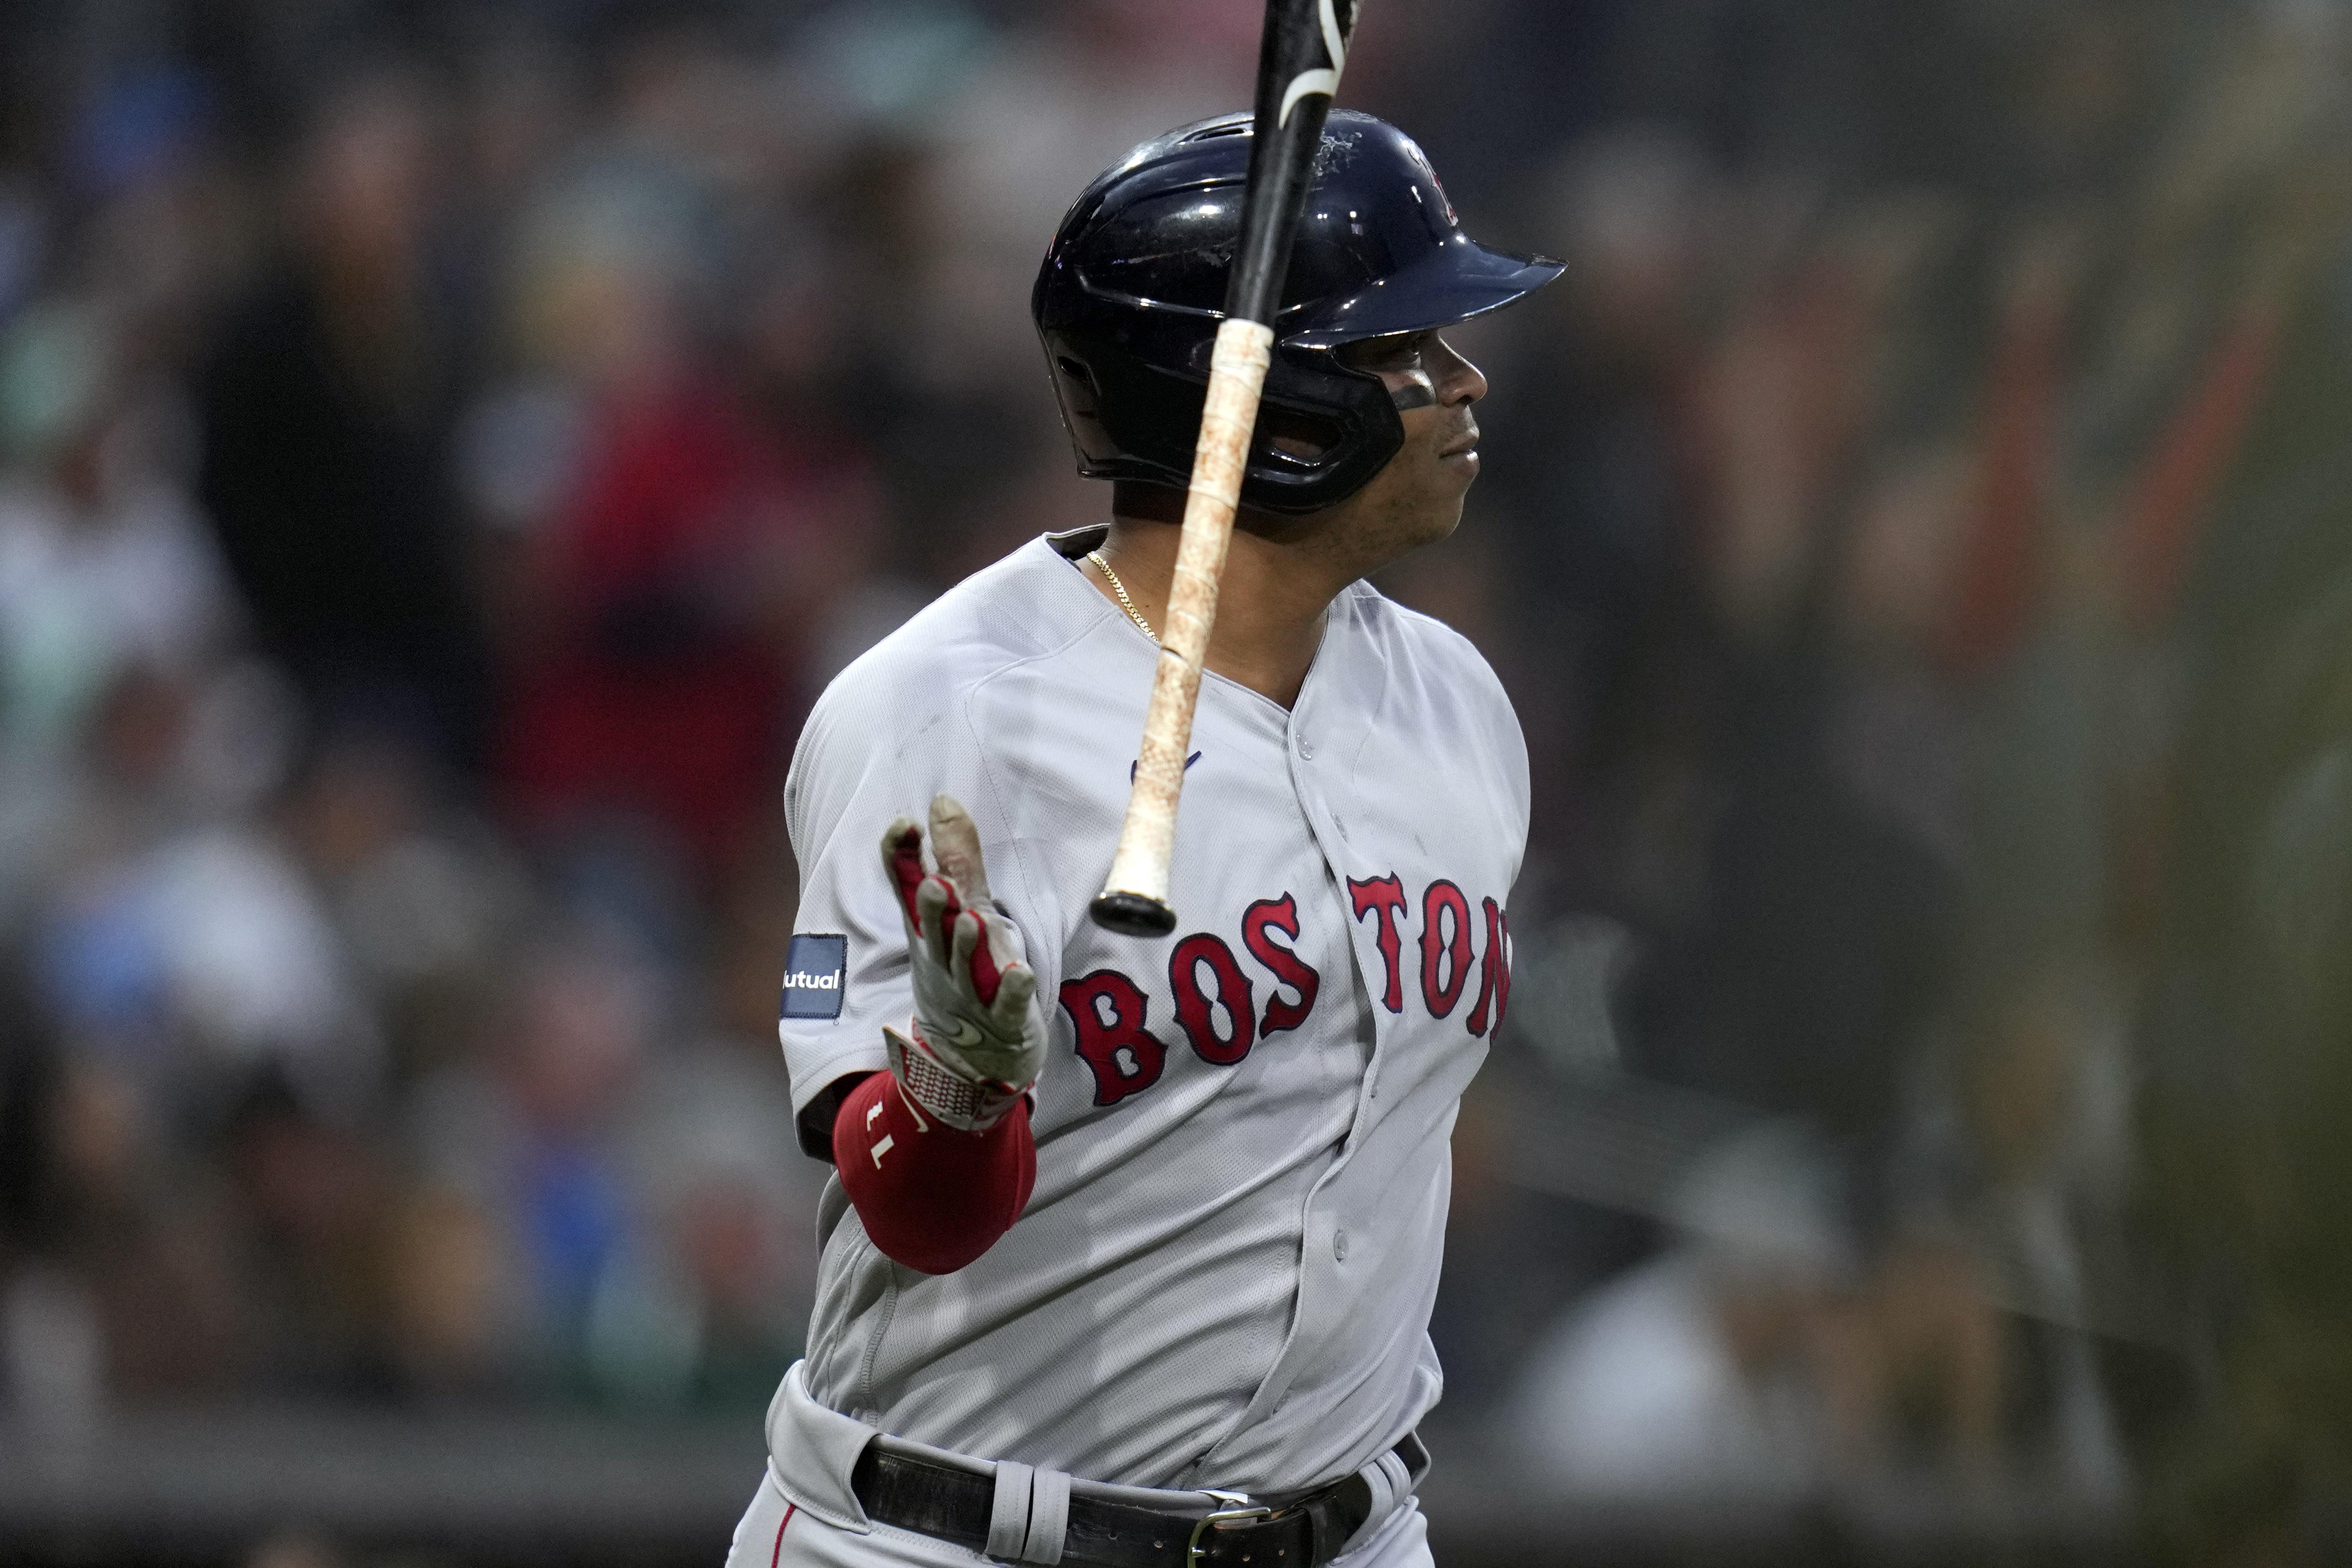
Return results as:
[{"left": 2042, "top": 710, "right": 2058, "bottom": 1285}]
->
[{"left": 1092, "top": 0, "right": 1355, "bottom": 936}]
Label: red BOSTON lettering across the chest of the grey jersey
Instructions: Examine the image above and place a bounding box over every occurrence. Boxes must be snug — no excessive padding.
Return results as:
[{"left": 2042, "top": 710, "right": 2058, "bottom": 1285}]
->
[{"left": 1061, "top": 877, "right": 1510, "bottom": 1105}]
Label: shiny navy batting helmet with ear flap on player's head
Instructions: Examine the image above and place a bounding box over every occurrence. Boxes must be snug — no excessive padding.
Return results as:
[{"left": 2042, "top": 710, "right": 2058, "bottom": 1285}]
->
[{"left": 1030, "top": 108, "right": 1562, "bottom": 513}]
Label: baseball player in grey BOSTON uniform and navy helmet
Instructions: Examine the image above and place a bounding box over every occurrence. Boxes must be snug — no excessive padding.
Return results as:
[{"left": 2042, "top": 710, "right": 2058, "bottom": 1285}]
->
[{"left": 729, "top": 111, "right": 1559, "bottom": 1568}]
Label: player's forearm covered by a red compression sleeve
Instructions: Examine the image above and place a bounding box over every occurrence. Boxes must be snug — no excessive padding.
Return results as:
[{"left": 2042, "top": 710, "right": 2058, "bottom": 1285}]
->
[{"left": 832, "top": 1072, "right": 1037, "bottom": 1274}]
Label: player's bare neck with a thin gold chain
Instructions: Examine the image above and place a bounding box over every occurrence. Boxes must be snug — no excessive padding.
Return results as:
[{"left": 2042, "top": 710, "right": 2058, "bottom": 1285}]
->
[{"left": 1086, "top": 494, "right": 1359, "bottom": 707}]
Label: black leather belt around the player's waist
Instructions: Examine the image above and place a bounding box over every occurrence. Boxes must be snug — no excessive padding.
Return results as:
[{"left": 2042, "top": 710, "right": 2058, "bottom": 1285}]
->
[{"left": 849, "top": 1434, "right": 1430, "bottom": 1568}]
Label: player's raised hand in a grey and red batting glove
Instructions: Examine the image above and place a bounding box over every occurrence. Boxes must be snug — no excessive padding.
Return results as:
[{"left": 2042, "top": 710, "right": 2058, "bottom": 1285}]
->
[{"left": 882, "top": 794, "right": 1044, "bottom": 1131}]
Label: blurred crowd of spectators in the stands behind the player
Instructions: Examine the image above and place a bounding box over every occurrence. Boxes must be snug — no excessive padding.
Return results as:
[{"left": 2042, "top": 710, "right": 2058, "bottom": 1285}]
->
[{"left": 0, "top": 0, "right": 2352, "bottom": 1566}]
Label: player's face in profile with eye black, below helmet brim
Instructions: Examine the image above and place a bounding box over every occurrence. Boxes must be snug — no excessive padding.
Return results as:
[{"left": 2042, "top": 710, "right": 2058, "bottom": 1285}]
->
[{"left": 1336, "top": 331, "right": 1486, "bottom": 571}]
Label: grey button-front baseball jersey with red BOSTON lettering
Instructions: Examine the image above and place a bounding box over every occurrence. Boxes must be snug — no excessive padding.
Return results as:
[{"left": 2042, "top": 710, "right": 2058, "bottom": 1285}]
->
[{"left": 781, "top": 529, "right": 1527, "bottom": 1493}]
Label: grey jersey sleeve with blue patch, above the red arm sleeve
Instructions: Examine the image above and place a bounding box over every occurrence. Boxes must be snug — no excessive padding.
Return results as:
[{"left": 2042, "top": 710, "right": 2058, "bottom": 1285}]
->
[{"left": 776, "top": 665, "right": 1054, "bottom": 1159}]
